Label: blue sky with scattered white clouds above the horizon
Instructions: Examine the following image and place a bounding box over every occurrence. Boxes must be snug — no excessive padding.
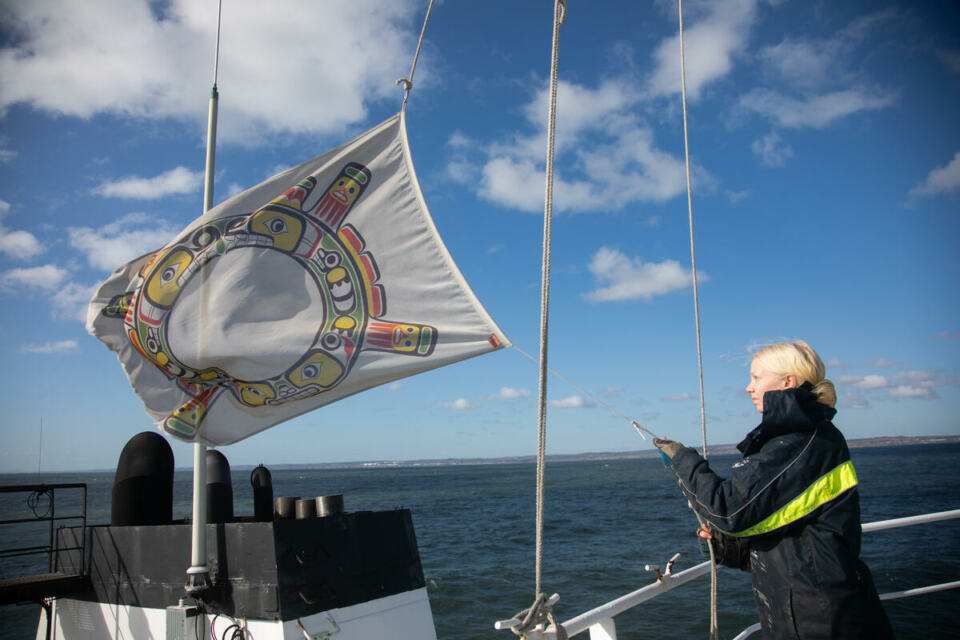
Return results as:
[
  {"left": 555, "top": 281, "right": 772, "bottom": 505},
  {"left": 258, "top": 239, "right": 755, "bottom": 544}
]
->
[{"left": 0, "top": 0, "right": 960, "bottom": 472}]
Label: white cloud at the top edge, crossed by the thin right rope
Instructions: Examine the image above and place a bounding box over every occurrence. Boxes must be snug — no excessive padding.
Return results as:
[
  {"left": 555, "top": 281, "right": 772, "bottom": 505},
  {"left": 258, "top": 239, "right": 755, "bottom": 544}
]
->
[{"left": 647, "top": 0, "right": 757, "bottom": 100}]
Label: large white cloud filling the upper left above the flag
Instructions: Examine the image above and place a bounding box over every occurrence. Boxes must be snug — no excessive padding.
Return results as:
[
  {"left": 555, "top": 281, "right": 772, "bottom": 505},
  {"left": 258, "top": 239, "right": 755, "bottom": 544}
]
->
[{"left": 0, "top": 0, "right": 420, "bottom": 145}]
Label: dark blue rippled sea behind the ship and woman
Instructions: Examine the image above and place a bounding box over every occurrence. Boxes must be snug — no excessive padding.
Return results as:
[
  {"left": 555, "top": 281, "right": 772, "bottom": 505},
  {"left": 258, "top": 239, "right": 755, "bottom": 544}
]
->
[{"left": 0, "top": 444, "right": 960, "bottom": 640}]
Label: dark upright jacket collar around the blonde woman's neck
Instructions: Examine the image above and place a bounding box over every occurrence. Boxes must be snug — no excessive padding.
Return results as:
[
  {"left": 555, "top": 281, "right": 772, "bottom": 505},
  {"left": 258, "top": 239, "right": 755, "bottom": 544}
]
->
[{"left": 737, "top": 382, "right": 837, "bottom": 456}]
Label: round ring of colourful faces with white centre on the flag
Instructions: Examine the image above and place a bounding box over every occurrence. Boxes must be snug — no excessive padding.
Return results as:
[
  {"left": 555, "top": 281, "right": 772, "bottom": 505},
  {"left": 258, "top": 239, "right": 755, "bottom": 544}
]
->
[{"left": 126, "top": 205, "right": 368, "bottom": 416}]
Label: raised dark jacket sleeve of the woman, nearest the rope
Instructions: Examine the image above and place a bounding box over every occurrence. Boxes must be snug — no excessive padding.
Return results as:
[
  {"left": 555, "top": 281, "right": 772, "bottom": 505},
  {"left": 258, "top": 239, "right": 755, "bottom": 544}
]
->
[{"left": 670, "top": 438, "right": 804, "bottom": 536}]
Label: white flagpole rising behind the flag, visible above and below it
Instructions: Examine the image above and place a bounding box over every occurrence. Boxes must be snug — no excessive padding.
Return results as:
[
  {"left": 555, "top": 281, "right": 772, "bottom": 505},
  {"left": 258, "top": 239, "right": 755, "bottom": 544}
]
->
[{"left": 186, "top": 3, "right": 223, "bottom": 597}]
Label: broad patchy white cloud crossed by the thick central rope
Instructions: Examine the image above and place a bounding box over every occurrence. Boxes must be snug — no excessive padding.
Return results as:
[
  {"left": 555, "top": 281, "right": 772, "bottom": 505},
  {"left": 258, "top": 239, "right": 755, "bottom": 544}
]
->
[{"left": 445, "top": 78, "right": 696, "bottom": 212}]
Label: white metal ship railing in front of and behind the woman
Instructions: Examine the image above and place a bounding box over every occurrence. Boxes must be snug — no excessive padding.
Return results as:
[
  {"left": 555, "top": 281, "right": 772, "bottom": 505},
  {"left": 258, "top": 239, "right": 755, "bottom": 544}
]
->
[{"left": 494, "top": 509, "right": 960, "bottom": 640}]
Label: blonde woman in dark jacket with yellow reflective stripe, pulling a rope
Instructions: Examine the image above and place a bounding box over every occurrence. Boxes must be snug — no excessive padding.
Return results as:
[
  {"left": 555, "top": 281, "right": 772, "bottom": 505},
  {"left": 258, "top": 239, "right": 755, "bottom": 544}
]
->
[{"left": 654, "top": 341, "right": 893, "bottom": 640}]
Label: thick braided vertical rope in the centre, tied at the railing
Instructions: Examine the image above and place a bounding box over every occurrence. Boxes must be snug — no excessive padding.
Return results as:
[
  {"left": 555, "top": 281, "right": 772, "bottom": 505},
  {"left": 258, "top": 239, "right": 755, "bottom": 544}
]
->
[{"left": 534, "top": 0, "right": 567, "bottom": 598}]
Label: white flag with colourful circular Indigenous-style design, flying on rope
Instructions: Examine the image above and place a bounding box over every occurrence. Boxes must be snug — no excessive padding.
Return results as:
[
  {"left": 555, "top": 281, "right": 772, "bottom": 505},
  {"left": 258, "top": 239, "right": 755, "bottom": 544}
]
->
[{"left": 87, "top": 114, "right": 509, "bottom": 445}]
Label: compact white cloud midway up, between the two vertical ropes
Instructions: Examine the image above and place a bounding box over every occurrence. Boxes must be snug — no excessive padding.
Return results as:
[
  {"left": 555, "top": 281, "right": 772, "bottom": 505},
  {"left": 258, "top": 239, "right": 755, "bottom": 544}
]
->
[{"left": 584, "top": 247, "right": 709, "bottom": 302}]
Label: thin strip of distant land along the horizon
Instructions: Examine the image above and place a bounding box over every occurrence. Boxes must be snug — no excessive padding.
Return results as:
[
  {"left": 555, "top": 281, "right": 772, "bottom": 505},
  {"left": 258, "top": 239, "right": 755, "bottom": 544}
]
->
[{"left": 255, "top": 435, "right": 960, "bottom": 470}]
